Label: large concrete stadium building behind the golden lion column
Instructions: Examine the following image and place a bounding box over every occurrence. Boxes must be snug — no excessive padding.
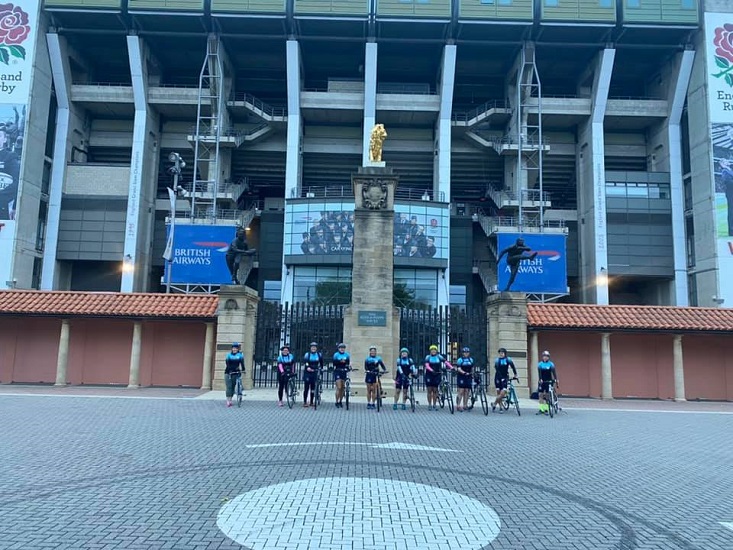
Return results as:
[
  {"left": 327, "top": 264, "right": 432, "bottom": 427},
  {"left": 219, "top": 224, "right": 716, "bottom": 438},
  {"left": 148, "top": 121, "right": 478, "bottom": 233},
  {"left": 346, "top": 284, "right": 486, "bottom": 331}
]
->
[{"left": 0, "top": 0, "right": 733, "bottom": 306}]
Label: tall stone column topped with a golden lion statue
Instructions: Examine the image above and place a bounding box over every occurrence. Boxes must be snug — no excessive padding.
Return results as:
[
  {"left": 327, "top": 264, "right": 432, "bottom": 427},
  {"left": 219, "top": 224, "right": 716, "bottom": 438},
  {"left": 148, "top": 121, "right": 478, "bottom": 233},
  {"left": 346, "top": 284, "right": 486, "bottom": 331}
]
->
[{"left": 344, "top": 124, "right": 400, "bottom": 394}]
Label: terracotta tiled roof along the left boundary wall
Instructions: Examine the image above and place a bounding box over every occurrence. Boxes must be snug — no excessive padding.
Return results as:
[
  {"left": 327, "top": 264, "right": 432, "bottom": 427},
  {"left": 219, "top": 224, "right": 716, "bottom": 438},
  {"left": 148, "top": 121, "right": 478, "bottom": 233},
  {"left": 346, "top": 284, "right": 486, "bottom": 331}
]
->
[{"left": 0, "top": 290, "right": 219, "bottom": 319}]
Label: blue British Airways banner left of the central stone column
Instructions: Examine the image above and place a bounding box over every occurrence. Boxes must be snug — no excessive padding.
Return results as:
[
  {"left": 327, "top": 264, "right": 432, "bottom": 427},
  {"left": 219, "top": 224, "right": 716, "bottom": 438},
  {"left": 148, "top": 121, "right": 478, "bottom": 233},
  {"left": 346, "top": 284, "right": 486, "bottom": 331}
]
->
[{"left": 165, "top": 224, "right": 236, "bottom": 285}]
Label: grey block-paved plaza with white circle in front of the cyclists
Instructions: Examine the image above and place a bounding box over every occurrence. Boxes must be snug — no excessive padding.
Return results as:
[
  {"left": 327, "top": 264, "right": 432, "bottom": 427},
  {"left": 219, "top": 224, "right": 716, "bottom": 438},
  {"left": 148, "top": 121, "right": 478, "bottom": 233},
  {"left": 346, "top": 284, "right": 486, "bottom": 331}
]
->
[{"left": 0, "top": 388, "right": 733, "bottom": 550}]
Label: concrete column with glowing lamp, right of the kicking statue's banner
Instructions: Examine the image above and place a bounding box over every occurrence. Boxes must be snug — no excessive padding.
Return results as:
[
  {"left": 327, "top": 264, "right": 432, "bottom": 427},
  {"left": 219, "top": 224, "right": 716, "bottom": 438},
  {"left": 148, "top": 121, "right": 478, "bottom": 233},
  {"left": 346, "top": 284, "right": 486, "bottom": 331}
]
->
[{"left": 577, "top": 48, "right": 616, "bottom": 304}]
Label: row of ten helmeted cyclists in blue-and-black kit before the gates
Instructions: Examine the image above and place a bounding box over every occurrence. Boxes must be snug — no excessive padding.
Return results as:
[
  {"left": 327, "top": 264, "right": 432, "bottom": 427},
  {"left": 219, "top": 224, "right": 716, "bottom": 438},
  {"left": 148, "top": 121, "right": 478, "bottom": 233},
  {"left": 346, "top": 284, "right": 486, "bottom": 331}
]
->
[{"left": 224, "top": 342, "right": 558, "bottom": 414}]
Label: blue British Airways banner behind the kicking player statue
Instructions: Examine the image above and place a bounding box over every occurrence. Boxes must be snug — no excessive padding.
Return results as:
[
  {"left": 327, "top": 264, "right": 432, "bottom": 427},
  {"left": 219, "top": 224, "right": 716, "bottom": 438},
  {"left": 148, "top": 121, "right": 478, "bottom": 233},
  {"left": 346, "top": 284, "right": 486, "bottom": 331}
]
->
[{"left": 497, "top": 233, "right": 568, "bottom": 294}]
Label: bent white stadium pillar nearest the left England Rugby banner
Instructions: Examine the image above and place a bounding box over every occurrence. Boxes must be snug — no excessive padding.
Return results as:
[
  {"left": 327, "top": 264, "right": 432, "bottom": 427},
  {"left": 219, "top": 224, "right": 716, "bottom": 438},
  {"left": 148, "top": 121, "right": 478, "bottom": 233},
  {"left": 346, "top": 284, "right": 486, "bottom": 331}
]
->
[{"left": 41, "top": 33, "right": 71, "bottom": 292}]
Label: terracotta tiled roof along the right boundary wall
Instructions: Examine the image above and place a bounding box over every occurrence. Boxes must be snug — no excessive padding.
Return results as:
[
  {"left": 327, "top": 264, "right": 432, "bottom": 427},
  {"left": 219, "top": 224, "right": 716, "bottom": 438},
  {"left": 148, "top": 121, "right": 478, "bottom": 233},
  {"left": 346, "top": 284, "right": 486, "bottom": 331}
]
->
[{"left": 527, "top": 303, "right": 733, "bottom": 332}]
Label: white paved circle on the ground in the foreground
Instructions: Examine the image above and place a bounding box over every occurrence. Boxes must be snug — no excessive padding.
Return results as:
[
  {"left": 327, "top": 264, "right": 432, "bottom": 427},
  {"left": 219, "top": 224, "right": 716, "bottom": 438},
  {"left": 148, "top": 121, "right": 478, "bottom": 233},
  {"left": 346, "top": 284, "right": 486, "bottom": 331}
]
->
[{"left": 216, "top": 477, "right": 501, "bottom": 550}]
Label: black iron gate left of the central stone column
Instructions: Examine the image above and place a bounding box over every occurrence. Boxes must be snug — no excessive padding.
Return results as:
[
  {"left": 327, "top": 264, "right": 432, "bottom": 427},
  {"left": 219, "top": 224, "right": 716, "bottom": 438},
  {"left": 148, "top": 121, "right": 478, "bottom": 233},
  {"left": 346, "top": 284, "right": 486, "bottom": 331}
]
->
[{"left": 252, "top": 301, "right": 344, "bottom": 388}]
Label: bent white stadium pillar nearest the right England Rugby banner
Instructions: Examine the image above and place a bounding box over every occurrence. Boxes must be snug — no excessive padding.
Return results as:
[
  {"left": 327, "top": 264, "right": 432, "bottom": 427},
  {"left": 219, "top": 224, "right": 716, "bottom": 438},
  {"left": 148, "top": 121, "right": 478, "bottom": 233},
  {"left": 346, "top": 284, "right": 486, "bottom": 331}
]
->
[{"left": 667, "top": 50, "right": 695, "bottom": 306}]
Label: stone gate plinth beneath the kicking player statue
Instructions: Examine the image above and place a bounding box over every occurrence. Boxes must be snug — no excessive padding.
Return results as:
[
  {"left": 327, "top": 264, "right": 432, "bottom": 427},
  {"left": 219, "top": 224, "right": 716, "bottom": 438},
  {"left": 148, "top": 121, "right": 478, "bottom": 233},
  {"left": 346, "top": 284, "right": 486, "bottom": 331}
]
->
[{"left": 486, "top": 292, "right": 537, "bottom": 398}]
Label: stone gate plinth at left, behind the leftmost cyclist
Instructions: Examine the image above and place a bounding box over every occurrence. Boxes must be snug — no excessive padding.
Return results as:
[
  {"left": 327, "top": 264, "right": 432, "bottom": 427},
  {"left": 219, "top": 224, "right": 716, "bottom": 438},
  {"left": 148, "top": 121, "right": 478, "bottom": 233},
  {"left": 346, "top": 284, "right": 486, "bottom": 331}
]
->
[{"left": 212, "top": 285, "right": 260, "bottom": 391}]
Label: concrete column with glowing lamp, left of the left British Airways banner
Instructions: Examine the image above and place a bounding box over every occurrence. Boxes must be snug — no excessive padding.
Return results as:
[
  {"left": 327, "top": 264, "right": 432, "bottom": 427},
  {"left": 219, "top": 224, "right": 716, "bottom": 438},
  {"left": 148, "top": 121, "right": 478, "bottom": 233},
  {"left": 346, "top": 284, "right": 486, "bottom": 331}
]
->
[{"left": 120, "top": 36, "right": 158, "bottom": 292}]
